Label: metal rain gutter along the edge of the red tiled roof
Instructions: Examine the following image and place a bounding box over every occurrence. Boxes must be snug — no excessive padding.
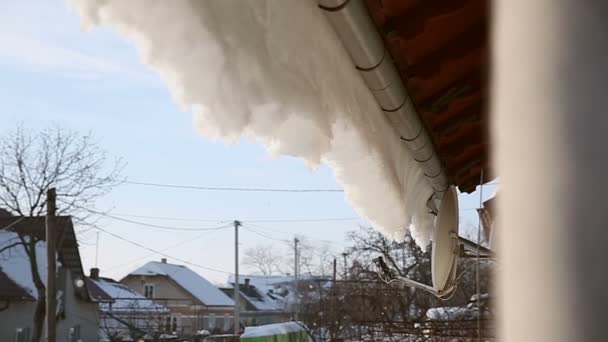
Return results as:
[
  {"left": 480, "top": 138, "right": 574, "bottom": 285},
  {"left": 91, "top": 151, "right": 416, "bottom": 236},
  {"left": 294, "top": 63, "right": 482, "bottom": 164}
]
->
[{"left": 319, "top": 0, "right": 449, "bottom": 208}]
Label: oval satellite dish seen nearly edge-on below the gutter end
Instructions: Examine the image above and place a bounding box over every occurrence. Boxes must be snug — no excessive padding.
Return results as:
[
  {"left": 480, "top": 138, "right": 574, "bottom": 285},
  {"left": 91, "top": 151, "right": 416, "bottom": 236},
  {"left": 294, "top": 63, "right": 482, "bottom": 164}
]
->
[{"left": 431, "top": 186, "right": 458, "bottom": 297}]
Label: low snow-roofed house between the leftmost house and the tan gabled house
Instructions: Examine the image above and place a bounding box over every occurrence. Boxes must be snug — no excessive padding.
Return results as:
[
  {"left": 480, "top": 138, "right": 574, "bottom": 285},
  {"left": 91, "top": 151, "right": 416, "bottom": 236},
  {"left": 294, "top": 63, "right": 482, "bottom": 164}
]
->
[{"left": 87, "top": 268, "right": 173, "bottom": 342}]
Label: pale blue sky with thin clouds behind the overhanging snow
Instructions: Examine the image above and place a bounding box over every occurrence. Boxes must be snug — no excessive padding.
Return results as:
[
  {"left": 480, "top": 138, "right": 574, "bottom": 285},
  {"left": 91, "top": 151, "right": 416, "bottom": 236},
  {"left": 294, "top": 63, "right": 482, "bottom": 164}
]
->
[{"left": 0, "top": 0, "right": 498, "bottom": 283}]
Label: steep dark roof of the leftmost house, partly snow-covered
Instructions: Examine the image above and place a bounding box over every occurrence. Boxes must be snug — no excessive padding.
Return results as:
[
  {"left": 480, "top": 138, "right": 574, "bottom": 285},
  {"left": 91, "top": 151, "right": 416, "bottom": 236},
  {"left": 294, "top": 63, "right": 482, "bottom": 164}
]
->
[{"left": 0, "top": 216, "right": 90, "bottom": 300}]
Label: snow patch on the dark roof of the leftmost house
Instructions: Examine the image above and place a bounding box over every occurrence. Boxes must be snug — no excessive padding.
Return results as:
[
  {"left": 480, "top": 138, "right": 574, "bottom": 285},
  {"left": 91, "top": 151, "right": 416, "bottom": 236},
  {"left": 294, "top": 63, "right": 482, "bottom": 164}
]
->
[{"left": 0, "top": 230, "right": 46, "bottom": 298}]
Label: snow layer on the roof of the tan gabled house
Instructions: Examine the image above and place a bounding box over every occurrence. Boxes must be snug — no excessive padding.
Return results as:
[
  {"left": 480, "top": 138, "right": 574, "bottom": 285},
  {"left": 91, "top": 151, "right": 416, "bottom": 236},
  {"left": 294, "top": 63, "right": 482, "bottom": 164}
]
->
[{"left": 129, "top": 261, "right": 234, "bottom": 306}]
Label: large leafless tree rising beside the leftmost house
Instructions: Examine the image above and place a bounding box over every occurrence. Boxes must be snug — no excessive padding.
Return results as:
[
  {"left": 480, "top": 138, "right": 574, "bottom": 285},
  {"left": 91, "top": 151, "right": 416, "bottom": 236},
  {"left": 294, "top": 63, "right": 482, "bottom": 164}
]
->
[{"left": 0, "top": 126, "right": 123, "bottom": 342}]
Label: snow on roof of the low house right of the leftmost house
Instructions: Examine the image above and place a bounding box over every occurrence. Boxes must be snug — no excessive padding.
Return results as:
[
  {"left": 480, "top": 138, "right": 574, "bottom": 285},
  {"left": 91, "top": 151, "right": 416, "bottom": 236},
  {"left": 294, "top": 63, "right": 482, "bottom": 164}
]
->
[{"left": 89, "top": 278, "right": 168, "bottom": 312}]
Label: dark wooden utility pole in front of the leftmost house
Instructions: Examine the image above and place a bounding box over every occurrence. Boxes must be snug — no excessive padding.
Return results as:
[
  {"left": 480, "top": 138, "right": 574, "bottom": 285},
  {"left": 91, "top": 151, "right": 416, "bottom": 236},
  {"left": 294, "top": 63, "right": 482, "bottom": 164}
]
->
[{"left": 46, "top": 188, "right": 57, "bottom": 342}]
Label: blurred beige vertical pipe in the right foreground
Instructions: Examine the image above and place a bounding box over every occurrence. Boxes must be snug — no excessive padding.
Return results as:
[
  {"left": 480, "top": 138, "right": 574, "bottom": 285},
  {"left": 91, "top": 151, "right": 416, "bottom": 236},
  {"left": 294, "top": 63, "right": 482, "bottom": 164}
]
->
[{"left": 492, "top": 0, "right": 608, "bottom": 342}]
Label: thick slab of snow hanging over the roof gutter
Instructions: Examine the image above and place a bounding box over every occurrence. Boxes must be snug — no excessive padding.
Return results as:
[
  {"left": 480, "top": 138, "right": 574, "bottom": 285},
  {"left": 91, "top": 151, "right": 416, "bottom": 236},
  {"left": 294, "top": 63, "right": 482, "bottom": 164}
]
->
[{"left": 67, "top": 0, "right": 433, "bottom": 245}]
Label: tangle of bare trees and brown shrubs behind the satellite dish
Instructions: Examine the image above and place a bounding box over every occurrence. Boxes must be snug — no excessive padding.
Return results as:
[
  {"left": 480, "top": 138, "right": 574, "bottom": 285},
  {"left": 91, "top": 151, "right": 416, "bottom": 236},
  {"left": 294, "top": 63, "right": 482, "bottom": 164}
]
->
[{"left": 301, "top": 227, "right": 491, "bottom": 340}]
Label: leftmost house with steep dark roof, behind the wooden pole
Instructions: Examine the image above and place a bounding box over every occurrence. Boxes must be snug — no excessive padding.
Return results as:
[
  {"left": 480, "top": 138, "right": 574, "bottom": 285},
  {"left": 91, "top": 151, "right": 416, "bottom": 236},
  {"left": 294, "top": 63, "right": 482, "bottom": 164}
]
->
[{"left": 0, "top": 216, "right": 99, "bottom": 342}]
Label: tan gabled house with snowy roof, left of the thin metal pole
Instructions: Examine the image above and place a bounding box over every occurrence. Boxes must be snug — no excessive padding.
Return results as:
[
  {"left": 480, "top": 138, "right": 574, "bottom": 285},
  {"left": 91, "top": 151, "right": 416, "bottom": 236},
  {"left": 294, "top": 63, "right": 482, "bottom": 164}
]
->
[{"left": 120, "top": 259, "right": 234, "bottom": 335}]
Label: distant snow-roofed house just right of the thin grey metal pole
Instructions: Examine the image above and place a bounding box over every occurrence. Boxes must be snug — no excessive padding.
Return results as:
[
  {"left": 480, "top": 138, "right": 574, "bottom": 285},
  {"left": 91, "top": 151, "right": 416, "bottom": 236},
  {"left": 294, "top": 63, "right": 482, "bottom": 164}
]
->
[{"left": 221, "top": 276, "right": 293, "bottom": 326}]
